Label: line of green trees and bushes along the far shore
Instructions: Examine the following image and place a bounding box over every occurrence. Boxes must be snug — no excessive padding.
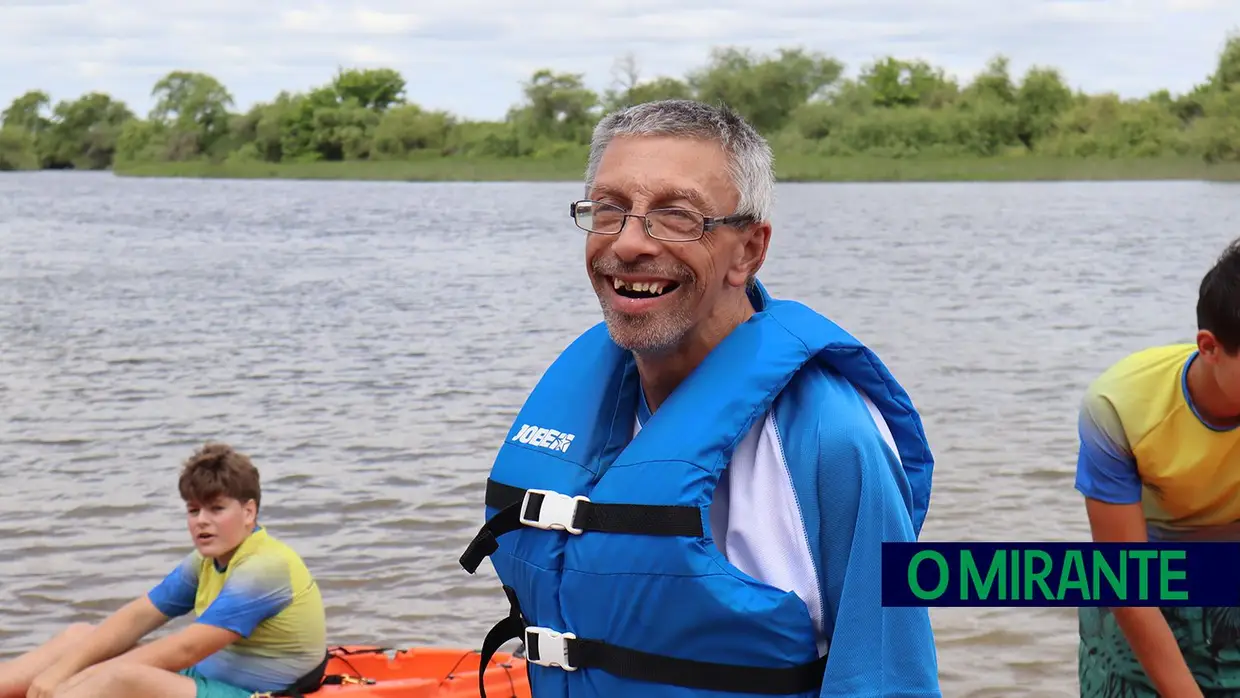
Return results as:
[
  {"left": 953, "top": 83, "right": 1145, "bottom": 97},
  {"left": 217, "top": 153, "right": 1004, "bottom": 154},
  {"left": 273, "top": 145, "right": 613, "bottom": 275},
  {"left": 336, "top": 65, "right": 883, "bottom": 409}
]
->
[{"left": 0, "top": 33, "right": 1240, "bottom": 170}]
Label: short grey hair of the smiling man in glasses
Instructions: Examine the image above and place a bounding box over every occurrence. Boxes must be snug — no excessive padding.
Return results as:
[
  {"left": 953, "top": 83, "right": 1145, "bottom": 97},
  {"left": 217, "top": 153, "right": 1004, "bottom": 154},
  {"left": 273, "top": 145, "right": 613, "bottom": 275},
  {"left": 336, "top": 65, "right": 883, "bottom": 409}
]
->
[{"left": 585, "top": 99, "right": 775, "bottom": 221}]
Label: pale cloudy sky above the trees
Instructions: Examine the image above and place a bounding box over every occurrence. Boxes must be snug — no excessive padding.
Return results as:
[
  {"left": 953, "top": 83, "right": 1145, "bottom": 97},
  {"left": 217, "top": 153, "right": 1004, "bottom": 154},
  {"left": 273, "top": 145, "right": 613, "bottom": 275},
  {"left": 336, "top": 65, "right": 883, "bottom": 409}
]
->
[{"left": 0, "top": 0, "right": 1240, "bottom": 119}]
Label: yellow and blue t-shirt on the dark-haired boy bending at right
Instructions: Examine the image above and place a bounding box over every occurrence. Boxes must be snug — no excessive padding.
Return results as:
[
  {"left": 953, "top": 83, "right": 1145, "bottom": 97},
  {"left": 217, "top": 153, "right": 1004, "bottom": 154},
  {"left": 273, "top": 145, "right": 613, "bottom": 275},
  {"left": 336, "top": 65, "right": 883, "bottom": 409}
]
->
[{"left": 1076, "top": 345, "right": 1240, "bottom": 541}]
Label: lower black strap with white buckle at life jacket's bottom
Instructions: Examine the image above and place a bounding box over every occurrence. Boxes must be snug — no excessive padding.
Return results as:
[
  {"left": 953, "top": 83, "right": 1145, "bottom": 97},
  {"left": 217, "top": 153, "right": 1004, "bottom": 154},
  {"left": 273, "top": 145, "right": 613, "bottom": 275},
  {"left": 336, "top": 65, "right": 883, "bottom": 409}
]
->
[{"left": 468, "top": 585, "right": 827, "bottom": 698}]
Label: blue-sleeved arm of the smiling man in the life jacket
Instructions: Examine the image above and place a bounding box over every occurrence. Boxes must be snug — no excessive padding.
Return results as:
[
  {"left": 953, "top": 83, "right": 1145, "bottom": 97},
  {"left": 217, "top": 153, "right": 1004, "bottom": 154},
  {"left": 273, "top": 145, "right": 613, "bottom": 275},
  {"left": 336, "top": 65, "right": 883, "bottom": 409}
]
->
[{"left": 818, "top": 411, "right": 942, "bottom": 698}]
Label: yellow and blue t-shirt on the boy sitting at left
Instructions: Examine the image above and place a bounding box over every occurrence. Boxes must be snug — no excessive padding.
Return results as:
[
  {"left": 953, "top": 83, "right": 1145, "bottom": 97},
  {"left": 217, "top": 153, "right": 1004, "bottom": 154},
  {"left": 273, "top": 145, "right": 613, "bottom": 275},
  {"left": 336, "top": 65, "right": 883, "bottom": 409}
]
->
[{"left": 148, "top": 527, "right": 327, "bottom": 692}]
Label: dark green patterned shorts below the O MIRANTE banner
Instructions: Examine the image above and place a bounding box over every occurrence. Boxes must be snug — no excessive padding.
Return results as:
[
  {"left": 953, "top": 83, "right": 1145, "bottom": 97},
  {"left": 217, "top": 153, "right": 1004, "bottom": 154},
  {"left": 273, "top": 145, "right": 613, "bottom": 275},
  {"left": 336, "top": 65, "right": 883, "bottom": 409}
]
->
[{"left": 1078, "top": 606, "right": 1240, "bottom": 698}]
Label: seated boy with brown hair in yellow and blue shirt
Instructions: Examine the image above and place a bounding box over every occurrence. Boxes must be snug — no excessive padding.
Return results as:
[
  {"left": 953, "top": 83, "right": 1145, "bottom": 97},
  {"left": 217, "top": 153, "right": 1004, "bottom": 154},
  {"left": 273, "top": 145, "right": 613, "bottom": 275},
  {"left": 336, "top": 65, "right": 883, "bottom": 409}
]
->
[{"left": 0, "top": 444, "right": 327, "bottom": 698}]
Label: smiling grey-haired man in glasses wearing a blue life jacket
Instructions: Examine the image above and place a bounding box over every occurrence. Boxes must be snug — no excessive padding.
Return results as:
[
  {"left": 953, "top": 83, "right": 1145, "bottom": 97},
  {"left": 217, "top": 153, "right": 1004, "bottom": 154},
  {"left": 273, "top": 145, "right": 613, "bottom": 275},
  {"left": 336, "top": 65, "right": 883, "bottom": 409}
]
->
[{"left": 461, "top": 100, "right": 940, "bottom": 698}]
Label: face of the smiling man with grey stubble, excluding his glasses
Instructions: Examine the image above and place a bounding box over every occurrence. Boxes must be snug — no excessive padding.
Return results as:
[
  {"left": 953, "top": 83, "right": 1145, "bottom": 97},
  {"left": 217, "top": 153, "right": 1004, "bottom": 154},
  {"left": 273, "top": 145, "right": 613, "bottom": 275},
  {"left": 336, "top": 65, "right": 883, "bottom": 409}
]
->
[{"left": 585, "top": 136, "right": 765, "bottom": 353}]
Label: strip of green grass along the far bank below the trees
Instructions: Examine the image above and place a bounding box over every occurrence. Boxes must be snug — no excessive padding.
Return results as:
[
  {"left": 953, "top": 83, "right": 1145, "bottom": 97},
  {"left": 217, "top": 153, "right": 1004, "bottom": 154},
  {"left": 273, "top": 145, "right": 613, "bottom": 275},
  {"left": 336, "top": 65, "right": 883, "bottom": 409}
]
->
[{"left": 114, "top": 154, "right": 1240, "bottom": 182}]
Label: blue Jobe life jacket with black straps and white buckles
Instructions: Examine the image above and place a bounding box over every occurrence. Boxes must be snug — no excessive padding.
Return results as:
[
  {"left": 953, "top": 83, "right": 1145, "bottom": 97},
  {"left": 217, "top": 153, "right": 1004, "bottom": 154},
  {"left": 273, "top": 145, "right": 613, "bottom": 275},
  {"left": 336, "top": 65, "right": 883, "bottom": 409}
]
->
[{"left": 460, "top": 285, "right": 932, "bottom": 698}]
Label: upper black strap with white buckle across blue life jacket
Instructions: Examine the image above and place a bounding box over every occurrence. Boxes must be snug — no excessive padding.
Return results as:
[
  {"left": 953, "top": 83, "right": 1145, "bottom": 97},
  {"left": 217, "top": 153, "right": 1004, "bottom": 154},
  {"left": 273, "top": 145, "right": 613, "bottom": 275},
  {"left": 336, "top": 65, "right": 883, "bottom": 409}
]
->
[{"left": 460, "top": 477, "right": 703, "bottom": 574}]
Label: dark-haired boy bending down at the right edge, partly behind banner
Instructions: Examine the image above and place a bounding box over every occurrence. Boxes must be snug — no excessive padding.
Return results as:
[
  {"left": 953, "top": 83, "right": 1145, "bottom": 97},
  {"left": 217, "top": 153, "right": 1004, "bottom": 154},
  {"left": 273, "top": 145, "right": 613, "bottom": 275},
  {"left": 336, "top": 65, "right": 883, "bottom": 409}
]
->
[{"left": 1076, "top": 241, "right": 1240, "bottom": 698}]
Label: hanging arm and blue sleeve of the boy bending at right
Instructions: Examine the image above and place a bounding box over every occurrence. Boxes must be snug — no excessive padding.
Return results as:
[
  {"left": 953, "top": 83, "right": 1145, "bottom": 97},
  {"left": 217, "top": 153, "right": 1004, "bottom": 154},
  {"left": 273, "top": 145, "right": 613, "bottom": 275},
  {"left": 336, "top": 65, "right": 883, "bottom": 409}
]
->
[{"left": 1076, "top": 386, "right": 1202, "bottom": 698}]
